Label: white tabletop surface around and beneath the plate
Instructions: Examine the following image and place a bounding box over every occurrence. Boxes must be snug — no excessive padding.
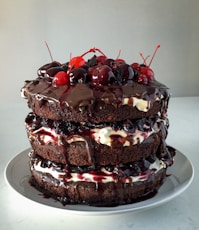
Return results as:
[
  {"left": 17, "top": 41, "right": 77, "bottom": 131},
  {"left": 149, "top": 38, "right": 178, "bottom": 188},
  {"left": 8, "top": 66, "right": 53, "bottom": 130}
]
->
[{"left": 0, "top": 97, "right": 199, "bottom": 230}]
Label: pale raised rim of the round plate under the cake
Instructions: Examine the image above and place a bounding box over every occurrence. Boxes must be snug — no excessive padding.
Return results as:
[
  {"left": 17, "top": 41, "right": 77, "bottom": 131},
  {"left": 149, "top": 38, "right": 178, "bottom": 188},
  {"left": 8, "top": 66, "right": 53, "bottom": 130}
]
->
[{"left": 4, "top": 148, "right": 194, "bottom": 216}]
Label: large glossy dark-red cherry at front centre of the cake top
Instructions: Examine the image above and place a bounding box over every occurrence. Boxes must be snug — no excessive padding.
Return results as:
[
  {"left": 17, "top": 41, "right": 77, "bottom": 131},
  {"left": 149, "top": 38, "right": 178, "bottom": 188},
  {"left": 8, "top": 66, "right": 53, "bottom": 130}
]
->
[{"left": 92, "top": 65, "right": 116, "bottom": 85}]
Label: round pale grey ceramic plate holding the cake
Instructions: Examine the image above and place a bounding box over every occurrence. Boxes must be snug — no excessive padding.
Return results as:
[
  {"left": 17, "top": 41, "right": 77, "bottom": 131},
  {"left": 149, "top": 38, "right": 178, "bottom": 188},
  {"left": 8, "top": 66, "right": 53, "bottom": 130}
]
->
[{"left": 5, "top": 149, "right": 194, "bottom": 215}]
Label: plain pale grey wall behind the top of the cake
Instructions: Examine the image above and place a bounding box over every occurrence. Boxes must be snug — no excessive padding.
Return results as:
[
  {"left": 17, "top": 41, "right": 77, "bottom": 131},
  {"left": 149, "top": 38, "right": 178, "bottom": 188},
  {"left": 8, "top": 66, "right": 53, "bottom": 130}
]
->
[{"left": 0, "top": 0, "right": 199, "bottom": 103}]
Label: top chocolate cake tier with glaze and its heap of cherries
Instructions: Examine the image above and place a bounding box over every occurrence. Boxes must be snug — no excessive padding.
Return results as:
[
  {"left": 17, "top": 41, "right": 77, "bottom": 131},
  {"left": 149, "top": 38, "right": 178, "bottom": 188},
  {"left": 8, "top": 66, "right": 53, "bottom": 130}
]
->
[{"left": 22, "top": 45, "right": 170, "bottom": 123}]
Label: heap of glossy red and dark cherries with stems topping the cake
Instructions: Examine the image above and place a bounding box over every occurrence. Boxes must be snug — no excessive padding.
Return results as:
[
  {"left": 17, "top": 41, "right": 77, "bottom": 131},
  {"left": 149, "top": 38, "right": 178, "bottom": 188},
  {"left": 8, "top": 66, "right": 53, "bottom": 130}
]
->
[{"left": 38, "top": 42, "right": 160, "bottom": 87}]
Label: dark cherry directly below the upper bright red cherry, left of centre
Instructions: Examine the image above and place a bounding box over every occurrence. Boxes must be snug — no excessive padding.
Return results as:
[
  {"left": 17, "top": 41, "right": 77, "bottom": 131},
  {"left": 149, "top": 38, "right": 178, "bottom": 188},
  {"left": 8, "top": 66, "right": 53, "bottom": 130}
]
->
[{"left": 69, "top": 68, "right": 87, "bottom": 84}]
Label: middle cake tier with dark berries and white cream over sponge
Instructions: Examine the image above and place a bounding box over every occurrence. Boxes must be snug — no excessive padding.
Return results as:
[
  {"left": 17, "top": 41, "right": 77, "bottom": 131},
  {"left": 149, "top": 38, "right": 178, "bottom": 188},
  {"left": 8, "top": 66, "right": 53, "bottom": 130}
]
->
[{"left": 25, "top": 113, "right": 169, "bottom": 166}]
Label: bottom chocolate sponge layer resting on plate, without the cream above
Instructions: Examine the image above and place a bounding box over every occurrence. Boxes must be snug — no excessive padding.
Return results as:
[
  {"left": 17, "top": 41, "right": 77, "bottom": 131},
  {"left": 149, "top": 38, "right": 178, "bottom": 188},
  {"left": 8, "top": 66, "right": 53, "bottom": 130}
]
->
[{"left": 31, "top": 168, "right": 166, "bottom": 207}]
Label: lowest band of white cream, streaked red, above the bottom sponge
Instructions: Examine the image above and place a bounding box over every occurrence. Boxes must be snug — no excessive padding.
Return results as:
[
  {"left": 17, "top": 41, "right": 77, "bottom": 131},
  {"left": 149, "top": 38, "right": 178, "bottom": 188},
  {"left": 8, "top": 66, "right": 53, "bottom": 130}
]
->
[{"left": 31, "top": 159, "right": 166, "bottom": 183}]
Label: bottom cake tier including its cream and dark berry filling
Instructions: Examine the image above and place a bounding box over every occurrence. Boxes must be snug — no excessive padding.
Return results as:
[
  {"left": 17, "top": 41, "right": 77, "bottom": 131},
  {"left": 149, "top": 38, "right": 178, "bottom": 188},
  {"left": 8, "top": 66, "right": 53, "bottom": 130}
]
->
[{"left": 29, "top": 149, "right": 174, "bottom": 206}]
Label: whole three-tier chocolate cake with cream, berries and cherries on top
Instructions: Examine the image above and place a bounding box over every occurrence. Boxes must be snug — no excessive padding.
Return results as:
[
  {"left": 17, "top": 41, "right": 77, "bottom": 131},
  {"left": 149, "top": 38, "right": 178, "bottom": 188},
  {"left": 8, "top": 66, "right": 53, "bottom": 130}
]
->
[{"left": 21, "top": 46, "right": 175, "bottom": 206}]
